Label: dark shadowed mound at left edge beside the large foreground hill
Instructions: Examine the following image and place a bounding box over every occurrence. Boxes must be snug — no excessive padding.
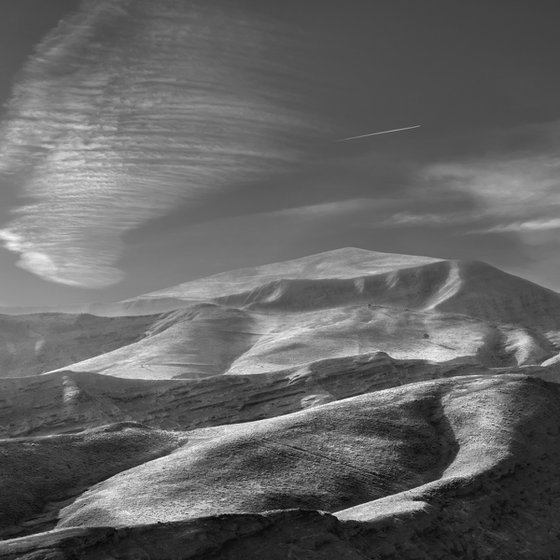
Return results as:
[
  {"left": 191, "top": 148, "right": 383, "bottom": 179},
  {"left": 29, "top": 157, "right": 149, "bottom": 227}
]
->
[{"left": 0, "top": 424, "right": 186, "bottom": 536}]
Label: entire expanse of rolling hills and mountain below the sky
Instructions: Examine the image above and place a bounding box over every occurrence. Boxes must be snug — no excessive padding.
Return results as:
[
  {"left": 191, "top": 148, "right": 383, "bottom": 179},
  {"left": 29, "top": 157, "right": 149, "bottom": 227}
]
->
[{"left": 0, "top": 249, "right": 560, "bottom": 560}]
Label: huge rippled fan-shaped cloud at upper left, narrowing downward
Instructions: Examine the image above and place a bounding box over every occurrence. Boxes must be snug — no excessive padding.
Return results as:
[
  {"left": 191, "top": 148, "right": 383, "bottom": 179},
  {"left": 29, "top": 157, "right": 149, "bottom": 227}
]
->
[{"left": 0, "top": 0, "right": 325, "bottom": 288}]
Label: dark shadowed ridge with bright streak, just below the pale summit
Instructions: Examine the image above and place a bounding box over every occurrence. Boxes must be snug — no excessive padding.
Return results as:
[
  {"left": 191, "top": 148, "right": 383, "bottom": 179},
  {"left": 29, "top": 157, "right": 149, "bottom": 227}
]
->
[{"left": 219, "top": 261, "right": 560, "bottom": 329}]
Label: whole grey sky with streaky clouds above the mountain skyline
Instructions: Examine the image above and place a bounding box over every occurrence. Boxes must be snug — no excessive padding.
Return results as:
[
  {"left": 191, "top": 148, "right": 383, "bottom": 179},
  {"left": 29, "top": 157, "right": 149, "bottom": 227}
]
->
[{"left": 0, "top": 0, "right": 560, "bottom": 306}]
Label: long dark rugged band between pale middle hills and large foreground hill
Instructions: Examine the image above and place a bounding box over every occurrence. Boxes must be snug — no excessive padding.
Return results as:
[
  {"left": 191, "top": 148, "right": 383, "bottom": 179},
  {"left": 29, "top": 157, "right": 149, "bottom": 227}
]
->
[{"left": 0, "top": 354, "right": 498, "bottom": 436}]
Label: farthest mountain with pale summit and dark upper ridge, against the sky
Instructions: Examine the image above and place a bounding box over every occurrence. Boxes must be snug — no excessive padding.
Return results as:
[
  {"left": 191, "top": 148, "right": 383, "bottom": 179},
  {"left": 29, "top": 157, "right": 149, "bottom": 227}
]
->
[{"left": 121, "top": 247, "right": 560, "bottom": 328}]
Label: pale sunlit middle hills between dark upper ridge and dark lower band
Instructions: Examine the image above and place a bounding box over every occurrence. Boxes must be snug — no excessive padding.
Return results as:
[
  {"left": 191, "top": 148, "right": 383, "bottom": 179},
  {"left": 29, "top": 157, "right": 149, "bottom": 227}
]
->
[{"left": 58, "top": 304, "right": 560, "bottom": 379}]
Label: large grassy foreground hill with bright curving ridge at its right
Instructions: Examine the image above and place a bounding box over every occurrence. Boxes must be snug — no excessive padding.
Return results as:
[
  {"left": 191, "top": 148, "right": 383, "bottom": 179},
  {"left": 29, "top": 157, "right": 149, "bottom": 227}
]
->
[{"left": 52, "top": 375, "right": 560, "bottom": 557}]
